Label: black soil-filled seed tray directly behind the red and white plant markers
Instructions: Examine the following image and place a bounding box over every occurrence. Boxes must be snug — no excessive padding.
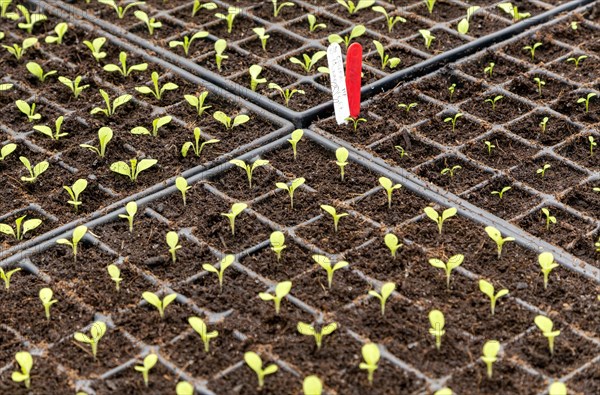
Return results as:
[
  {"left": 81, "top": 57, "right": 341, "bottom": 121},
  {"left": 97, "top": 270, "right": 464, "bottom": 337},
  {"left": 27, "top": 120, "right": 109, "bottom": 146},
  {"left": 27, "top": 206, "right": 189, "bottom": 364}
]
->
[{"left": 43, "top": 0, "right": 591, "bottom": 127}]
